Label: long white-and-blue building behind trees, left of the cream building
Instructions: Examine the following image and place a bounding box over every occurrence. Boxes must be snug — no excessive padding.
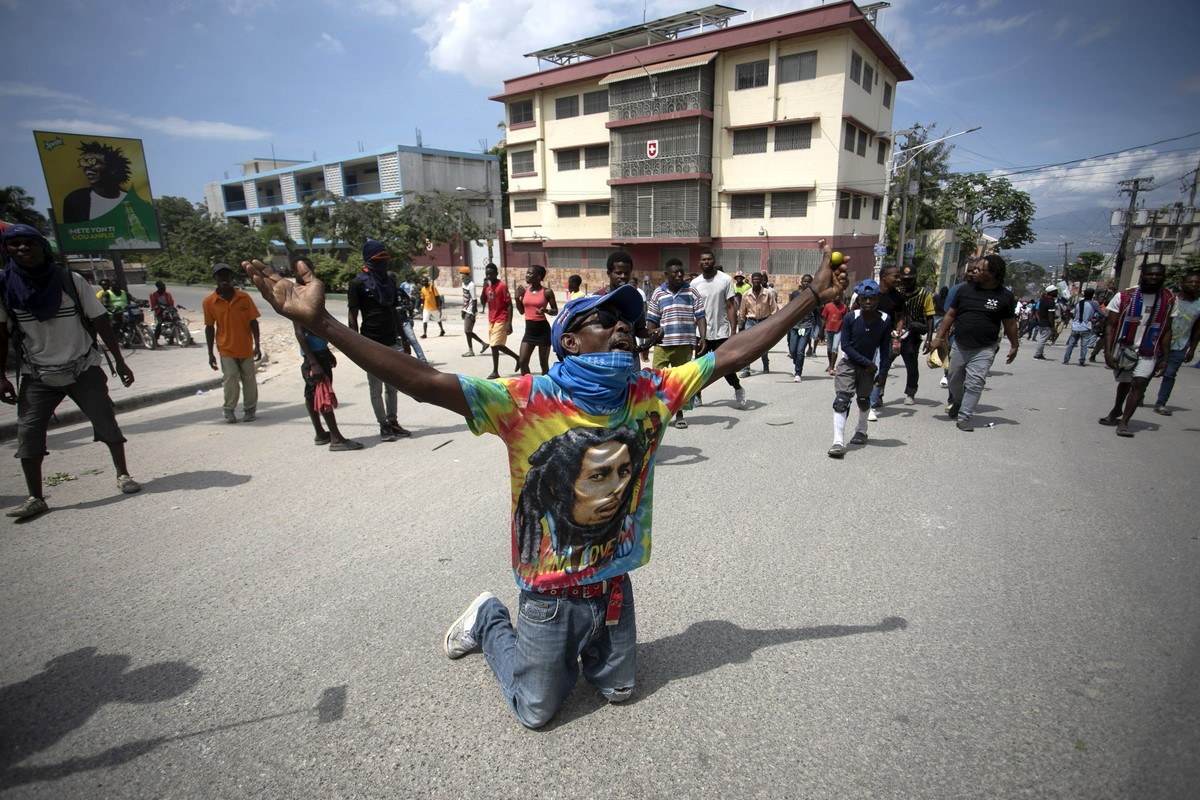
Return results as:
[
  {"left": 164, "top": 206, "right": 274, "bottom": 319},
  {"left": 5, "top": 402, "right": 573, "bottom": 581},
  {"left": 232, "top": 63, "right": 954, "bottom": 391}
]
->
[{"left": 204, "top": 145, "right": 500, "bottom": 273}]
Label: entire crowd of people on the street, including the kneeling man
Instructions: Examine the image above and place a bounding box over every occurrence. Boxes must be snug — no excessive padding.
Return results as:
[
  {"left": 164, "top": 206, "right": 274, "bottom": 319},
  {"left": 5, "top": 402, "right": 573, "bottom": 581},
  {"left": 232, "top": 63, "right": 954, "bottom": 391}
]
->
[{"left": 0, "top": 220, "right": 1200, "bottom": 727}]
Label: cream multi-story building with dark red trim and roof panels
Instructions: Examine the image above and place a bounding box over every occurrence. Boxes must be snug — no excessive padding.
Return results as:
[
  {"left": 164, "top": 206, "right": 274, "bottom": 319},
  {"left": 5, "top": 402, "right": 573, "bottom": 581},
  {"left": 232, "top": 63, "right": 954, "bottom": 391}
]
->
[{"left": 492, "top": 2, "right": 912, "bottom": 284}]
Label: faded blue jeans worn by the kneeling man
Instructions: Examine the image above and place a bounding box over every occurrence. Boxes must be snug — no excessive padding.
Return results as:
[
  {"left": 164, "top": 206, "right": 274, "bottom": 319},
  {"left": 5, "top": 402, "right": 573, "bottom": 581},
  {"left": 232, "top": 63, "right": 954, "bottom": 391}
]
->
[{"left": 472, "top": 576, "right": 637, "bottom": 728}]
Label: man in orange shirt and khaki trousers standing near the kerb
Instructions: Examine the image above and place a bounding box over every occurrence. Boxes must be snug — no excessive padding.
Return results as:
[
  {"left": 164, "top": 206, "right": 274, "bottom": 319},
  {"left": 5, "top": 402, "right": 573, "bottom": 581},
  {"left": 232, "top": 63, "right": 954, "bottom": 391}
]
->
[{"left": 204, "top": 264, "right": 263, "bottom": 422}]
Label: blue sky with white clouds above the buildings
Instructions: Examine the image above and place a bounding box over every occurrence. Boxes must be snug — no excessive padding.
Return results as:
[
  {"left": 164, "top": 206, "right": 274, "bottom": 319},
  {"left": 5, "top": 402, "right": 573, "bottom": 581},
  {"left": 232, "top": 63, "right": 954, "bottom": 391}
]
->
[{"left": 0, "top": 0, "right": 1200, "bottom": 266}]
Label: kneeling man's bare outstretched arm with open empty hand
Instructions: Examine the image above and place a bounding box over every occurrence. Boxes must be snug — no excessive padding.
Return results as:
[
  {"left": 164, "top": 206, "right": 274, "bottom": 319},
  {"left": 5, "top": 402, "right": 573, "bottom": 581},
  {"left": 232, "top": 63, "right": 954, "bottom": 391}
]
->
[{"left": 241, "top": 259, "right": 470, "bottom": 417}]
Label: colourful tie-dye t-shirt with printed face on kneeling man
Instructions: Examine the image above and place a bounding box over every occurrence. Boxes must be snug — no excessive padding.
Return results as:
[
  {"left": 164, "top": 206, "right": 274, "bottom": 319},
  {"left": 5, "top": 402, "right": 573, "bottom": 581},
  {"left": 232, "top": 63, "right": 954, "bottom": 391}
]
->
[{"left": 458, "top": 354, "right": 713, "bottom": 590}]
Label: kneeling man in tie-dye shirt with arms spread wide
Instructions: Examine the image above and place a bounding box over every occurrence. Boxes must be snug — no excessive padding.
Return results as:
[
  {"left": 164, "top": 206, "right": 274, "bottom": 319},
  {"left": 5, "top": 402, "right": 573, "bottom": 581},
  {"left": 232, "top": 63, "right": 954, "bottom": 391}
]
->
[{"left": 242, "top": 247, "right": 846, "bottom": 728}]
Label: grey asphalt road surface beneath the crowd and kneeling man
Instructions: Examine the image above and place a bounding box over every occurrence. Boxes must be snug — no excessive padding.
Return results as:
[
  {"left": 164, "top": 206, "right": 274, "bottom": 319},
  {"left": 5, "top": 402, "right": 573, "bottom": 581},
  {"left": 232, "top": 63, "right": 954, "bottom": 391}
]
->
[{"left": 0, "top": 291, "right": 1200, "bottom": 799}]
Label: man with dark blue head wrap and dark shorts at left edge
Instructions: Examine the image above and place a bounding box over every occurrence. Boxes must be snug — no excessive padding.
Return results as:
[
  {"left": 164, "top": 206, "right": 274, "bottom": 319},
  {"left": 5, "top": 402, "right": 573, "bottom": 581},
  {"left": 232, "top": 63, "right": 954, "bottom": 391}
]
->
[{"left": 0, "top": 224, "right": 142, "bottom": 519}]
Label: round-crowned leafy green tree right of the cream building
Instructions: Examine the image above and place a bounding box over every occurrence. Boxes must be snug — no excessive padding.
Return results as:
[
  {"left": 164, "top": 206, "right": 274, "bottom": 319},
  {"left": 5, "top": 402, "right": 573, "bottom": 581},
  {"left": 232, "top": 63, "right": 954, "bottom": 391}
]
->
[{"left": 937, "top": 173, "right": 1037, "bottom": 267}]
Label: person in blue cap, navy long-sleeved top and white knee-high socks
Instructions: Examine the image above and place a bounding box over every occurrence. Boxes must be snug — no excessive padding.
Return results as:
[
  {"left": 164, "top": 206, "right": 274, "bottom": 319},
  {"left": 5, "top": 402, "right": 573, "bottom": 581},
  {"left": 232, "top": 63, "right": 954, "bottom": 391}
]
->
[{"left": 828, "top": 278, "right": 894, "bottom": 458}]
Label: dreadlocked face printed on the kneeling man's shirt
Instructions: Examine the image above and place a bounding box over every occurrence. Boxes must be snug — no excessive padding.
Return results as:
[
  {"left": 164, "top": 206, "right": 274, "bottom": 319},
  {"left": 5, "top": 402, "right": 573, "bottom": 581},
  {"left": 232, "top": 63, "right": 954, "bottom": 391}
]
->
[{"left": 514, "top": 427, "right": 646, "bottom": 573}]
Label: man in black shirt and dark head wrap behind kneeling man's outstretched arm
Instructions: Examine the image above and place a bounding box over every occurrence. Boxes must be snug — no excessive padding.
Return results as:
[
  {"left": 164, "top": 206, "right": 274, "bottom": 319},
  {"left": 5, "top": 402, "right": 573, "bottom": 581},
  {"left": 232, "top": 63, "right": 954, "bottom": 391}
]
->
[{"left": 350, "top": 239, "right": 410, "bottom": 441}]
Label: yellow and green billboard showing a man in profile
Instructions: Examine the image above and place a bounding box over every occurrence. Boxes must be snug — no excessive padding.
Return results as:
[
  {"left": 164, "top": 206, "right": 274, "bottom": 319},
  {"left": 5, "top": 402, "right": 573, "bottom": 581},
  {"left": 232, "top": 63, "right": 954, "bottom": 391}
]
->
[{"left": 34, "top": 131, "right": 162, "bottom": 253}]
